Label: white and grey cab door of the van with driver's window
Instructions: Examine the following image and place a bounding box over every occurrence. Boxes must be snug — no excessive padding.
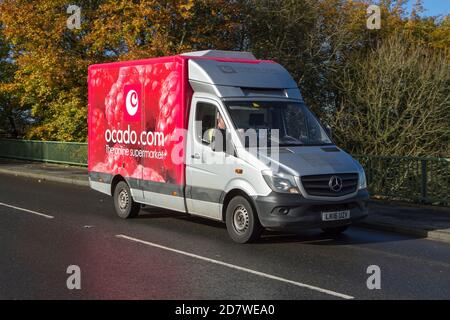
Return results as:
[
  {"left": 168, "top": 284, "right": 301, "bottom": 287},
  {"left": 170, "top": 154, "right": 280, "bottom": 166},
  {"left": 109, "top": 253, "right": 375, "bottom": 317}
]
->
[{"left": 186, "top": 98, "right": 237, "bottom": 220}]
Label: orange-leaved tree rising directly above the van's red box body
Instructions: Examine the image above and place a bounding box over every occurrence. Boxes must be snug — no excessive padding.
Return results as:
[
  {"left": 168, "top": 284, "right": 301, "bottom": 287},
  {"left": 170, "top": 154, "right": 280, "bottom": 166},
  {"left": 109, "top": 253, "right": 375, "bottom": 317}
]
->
[{"left": 87, "top": 0, "right": 244, "bottom": 59}]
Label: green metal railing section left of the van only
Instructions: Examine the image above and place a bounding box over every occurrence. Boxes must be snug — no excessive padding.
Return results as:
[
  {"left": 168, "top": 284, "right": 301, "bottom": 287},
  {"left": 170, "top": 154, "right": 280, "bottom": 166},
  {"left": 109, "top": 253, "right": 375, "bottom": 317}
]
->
[{"left": 0, "top": 139, "right": 87, "bottom": 166}]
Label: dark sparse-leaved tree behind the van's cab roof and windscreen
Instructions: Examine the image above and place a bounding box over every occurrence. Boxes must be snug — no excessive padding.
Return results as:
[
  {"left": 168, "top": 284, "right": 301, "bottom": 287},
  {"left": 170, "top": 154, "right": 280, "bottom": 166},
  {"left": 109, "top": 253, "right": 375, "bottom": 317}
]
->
[{"left": 244, "top": 0, "right": 384, "bottom": 116}]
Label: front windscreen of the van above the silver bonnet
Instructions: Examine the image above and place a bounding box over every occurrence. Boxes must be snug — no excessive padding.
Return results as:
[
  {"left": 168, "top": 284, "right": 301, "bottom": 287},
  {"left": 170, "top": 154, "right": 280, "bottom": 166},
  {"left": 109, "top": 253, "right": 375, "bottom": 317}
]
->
[{"left": 226, "top": 101, "right": 332, "bottom": 146}]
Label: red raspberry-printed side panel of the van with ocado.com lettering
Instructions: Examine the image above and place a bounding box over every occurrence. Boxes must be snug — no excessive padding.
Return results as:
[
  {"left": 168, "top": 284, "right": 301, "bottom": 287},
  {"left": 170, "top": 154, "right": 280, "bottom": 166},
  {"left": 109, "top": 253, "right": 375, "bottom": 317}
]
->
[{"left": 89, "top": 62, "right": 184, "bottom": 183}]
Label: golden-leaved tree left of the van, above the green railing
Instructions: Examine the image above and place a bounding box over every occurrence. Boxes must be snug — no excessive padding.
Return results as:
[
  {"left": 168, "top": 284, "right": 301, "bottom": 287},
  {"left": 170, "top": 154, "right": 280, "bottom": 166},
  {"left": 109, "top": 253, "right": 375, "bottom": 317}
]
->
[{"left": 0, "top": 1, "right": 95, "bottom": 141}]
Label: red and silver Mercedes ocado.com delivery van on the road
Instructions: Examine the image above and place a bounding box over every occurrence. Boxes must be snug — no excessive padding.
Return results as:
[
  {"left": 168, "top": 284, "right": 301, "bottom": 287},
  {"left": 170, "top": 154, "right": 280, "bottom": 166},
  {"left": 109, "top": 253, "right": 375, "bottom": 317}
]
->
[{"left": 88, "top": 50, "right": 369, "bottom": 243}]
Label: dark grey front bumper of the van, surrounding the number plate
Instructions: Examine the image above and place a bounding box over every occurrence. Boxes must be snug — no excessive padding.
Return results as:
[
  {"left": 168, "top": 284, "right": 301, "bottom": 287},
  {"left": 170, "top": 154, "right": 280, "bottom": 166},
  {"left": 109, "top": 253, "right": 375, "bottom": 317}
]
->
[{"left": 254, "top": 189, "right": 369, "bottom": 230}]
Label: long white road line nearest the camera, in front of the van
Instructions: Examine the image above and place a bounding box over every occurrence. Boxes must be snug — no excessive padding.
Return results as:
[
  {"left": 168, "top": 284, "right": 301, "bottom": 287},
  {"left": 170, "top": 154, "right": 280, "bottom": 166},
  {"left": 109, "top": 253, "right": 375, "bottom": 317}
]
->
[{"left": 116, "top": 234, "right": 354, "bottom": 299}]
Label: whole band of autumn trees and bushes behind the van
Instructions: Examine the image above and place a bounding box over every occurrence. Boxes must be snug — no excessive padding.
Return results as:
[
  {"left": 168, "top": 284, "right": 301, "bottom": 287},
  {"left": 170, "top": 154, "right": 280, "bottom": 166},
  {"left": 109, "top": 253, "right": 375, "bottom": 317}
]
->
[{"left": 0, "top": 0, "right": 450, "bottom": 155}]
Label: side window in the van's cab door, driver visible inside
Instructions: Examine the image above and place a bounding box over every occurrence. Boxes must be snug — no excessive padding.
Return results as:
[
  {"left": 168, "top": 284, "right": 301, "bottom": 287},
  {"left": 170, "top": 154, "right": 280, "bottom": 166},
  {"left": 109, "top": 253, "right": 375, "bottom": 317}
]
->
[{"left": 195, "top": 102, "right": 218, "bottom": 144}]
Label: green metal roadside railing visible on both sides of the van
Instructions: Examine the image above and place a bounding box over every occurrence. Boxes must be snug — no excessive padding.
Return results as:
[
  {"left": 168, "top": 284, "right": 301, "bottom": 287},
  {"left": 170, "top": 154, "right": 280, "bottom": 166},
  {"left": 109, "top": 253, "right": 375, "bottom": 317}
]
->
[{"left": 0, "top": 139, "right": 450, "bottom": 206}]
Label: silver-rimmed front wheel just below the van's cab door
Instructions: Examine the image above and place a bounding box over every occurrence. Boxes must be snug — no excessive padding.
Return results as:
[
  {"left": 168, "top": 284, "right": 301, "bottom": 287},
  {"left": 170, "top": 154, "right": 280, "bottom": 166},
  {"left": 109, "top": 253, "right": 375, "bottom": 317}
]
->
[{"left": 225, "top": 196, "right": 263, "bottom": 243}]
